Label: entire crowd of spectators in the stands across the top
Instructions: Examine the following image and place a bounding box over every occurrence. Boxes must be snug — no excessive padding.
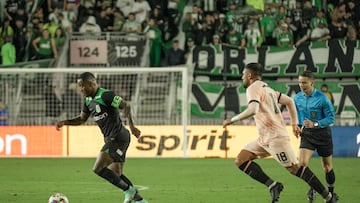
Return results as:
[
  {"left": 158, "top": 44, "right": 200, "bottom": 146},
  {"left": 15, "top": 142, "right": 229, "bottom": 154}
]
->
[{"left": 0, "top": 0, "right": 360, "bottom": 66}]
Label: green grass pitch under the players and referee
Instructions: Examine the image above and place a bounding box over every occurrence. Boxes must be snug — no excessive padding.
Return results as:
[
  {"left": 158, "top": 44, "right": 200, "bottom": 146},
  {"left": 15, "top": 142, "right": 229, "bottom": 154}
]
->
[{"left": 0, "top": 158, "right": 360, "bottom": 203}]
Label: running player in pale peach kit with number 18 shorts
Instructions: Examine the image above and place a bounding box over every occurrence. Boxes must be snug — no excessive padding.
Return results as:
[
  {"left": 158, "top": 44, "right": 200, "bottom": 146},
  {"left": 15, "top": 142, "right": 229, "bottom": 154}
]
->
[{"left": 223, "top": 63, "right": 336, "bottom": 203}]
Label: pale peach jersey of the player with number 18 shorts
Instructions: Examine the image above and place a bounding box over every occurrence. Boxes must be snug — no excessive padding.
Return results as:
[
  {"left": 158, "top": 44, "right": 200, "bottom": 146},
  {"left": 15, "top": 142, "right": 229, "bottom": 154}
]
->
[{"left": 246, "top": 80, "right": 289, "bottom": 145}]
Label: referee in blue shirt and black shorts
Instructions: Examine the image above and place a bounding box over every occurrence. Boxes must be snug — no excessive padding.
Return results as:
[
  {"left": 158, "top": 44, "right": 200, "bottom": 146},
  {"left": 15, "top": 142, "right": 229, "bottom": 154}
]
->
[{"left": 294, "top": 71, "right": 338, "bottom": 202}]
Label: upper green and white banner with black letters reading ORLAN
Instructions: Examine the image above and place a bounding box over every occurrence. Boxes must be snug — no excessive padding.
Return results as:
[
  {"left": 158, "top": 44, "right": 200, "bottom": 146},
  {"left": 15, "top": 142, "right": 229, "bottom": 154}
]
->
[{"left": 192, "top": 40, "right": 360, "bottom": 80}]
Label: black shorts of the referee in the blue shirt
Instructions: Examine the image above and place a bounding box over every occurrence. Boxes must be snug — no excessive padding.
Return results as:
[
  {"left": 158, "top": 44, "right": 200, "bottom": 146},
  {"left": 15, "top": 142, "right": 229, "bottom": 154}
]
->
[{"left": 300, "top": 127, "right": 333, "bottom": 157}]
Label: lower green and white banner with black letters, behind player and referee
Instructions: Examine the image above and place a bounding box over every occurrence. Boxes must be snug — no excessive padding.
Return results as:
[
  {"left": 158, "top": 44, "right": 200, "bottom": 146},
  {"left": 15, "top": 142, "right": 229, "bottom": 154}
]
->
[{"left": 191, "top": 79, "right": 360, "bottom": 118}]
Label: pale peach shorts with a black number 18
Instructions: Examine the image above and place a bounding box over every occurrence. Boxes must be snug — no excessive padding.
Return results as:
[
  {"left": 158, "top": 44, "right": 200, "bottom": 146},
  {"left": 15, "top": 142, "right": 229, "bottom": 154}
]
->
[{"left": 244, "top": 137, "right": 298, "bottom": 168}]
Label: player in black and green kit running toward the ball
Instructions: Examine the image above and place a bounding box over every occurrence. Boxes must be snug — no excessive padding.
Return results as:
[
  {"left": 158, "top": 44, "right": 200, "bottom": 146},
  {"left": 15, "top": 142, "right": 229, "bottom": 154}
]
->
[{"left": 56, "top": 72, "right": 147, "bottom": 203}]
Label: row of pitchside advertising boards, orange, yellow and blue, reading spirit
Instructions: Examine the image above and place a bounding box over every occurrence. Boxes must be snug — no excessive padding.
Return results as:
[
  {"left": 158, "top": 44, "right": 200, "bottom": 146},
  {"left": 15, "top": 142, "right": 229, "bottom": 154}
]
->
[{"left": 0, "top": 125, "right": 360, "bottom": 158}]
